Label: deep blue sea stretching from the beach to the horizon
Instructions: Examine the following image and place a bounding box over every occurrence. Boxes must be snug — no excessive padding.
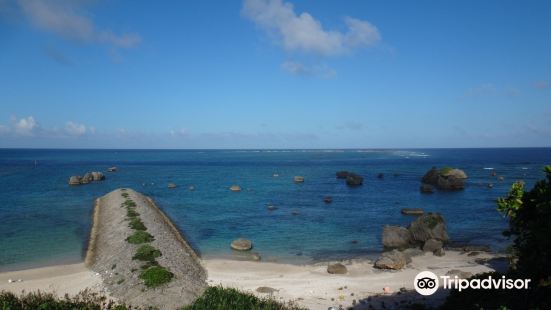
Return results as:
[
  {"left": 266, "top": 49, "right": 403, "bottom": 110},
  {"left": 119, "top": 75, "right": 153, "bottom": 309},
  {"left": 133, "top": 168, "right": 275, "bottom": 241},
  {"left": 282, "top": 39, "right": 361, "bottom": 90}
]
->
[{"left": 0, "top": 148, "right": 551, "bottom": 270}]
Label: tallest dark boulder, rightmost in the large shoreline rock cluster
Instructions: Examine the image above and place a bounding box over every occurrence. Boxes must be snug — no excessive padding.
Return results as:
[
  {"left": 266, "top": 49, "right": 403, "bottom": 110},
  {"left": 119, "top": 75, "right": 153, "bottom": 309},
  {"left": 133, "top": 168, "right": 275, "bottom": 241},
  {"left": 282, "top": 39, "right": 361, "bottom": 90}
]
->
[{"left": 408, "top": 212, "right": 449, "bottom": 244}]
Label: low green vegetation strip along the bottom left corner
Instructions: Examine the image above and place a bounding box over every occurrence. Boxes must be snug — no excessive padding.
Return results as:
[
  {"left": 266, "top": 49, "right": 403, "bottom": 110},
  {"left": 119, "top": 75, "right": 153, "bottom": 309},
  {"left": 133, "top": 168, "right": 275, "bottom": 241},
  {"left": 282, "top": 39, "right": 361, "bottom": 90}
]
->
[{"left": 0, "top": 291, "right": 128, "bottom": 310}]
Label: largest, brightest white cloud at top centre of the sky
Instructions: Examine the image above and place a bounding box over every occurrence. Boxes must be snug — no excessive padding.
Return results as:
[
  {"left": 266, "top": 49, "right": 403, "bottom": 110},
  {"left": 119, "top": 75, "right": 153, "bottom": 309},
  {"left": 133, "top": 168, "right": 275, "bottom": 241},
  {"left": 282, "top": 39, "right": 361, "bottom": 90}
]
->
[{"left": 242, "top": 0, "right": 381, "bottom": 56}]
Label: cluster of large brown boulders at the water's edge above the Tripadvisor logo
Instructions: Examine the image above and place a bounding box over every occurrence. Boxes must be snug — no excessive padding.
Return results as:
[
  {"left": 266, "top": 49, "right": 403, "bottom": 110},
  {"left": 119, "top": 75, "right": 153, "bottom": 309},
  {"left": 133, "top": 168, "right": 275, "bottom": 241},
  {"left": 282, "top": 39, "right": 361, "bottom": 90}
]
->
[{"left": 375, "top": 213, "right": 449, "bottom": 270}]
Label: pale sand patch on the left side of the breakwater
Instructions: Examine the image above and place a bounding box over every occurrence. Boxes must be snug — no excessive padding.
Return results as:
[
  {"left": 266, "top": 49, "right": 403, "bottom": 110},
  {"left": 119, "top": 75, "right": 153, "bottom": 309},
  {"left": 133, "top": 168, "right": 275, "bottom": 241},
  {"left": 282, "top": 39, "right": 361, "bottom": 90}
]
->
[{"left": 0, "top": 263, "right": 103, "bottom": 297}]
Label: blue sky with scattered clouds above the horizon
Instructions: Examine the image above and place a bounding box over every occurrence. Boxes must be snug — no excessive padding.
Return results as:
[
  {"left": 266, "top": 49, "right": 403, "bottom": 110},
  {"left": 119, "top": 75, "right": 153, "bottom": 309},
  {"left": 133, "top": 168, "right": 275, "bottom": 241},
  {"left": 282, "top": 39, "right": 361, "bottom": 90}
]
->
[{"left": 0, "top": 0, "right": 551, "bottom": 148}]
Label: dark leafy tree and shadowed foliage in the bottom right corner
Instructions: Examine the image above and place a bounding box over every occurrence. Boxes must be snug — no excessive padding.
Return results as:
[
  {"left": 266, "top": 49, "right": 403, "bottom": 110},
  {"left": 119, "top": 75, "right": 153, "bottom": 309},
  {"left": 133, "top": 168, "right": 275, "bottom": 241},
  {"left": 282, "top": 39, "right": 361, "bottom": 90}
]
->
[{"left": 442, "top": 166, "right": 551, "bottom": 309}]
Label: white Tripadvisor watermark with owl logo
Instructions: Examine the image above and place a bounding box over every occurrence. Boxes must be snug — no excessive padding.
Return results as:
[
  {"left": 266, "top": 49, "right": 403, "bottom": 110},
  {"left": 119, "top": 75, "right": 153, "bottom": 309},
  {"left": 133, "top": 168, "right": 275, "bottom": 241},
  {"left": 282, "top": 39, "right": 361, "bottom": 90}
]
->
[{"left": 413, "top": 271, "right": 530, "bottom": 296}]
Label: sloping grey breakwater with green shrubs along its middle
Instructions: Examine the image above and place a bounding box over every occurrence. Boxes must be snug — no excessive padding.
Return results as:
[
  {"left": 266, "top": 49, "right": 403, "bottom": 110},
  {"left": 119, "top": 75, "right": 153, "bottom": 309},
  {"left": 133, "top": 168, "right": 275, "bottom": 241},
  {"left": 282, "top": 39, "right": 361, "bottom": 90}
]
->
[{"left": 85, "top": 189, "right": 207, "bottom": 309}]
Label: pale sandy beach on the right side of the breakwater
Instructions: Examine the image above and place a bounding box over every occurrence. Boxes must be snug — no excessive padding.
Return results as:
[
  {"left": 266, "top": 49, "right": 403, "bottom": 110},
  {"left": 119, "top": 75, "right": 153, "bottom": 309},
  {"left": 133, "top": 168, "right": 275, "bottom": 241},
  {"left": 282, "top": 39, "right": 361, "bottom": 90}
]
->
[{"left": 203, "top": 251, "right": 502, "bottom": 310}]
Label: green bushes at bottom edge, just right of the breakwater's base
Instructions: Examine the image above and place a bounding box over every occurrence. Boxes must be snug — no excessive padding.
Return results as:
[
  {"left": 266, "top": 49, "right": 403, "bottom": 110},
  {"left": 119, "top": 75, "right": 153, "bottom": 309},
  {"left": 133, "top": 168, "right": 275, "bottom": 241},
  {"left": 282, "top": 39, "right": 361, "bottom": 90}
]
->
[{"left": 183, "top": 286, "right": 305, "bottom": 310}]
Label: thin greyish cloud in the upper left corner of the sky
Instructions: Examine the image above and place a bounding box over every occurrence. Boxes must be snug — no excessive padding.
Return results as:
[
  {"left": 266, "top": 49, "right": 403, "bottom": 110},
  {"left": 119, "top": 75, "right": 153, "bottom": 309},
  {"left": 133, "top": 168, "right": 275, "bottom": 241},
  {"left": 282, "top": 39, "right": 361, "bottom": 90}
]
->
[{"left": 18, "top": 0, "right": 141, "bottom": 48}]
